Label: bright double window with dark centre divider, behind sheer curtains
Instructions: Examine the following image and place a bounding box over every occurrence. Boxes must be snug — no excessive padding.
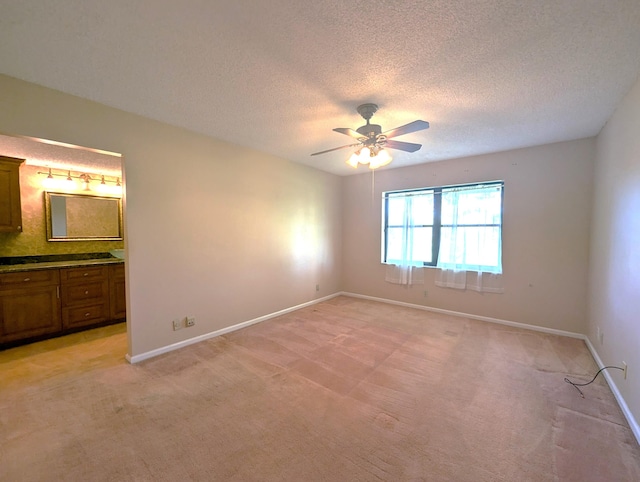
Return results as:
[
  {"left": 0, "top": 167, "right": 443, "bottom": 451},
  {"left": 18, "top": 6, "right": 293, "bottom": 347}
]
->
[{"left": 382, "top": 181, "right": 504, "bottom": 273}]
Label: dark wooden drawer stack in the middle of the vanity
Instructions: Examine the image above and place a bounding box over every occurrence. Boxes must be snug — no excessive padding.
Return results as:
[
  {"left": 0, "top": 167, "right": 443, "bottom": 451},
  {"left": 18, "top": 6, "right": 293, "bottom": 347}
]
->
[{"left": 60, "top": 265, "right": 110, "bottom": 330}]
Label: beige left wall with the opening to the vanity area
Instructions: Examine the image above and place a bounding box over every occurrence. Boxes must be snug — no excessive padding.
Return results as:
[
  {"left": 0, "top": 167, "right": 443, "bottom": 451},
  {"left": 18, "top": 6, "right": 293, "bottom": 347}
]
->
[{"left": 0, "top": 76, "right": 341, "bottom": 356}]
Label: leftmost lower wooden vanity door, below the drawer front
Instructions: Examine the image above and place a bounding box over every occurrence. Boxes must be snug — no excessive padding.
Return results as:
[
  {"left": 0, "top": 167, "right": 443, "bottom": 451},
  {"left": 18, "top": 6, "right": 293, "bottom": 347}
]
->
[{"left": 0, "top": 286, "right": 62, "bottom": 343}]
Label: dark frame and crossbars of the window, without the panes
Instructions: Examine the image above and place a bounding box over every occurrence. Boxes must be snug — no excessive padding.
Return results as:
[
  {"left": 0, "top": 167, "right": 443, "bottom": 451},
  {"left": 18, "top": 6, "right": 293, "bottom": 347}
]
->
[{"left": 381, "top": 180, "right": 504, "bottom": 268}]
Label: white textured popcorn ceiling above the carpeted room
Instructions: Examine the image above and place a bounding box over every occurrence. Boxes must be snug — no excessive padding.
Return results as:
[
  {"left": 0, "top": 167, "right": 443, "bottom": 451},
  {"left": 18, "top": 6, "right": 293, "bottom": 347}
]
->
[{"left": 0, "top": 0, "right": 640, "bottom": 174}]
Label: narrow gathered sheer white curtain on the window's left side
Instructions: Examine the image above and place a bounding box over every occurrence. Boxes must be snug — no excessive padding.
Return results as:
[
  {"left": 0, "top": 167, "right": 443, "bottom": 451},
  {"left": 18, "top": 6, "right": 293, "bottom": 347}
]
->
[{"left": 385, "top": 196, "right": 424, "bottom": 286}]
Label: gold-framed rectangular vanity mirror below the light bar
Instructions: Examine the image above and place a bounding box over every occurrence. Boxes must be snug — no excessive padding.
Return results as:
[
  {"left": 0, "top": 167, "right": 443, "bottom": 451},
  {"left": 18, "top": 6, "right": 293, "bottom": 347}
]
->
[{"left": 44, "top": 192, "right": 123, "bottom": 241}]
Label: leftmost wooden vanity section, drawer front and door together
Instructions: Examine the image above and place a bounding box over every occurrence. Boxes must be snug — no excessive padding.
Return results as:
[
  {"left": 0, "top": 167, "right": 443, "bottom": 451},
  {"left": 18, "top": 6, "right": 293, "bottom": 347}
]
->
[{"left": 0, "top": 270, "right": 62, "bottom": 343}]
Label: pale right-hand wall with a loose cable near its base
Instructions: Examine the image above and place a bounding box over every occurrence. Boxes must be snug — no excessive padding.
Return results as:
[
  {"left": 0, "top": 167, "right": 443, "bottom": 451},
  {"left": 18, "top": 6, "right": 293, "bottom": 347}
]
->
[{"left": 587, "top": 74, "right": 640, "bottom": 420}]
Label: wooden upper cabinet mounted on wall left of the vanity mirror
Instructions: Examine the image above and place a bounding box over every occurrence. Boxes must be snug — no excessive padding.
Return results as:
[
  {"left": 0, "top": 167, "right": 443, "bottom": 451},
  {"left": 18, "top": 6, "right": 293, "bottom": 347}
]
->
[{"left": 0, "top": 156, "right": 24, "bottom": 233}]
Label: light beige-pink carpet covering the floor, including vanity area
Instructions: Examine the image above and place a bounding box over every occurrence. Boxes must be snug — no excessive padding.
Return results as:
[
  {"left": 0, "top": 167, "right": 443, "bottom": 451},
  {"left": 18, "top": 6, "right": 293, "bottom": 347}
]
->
[{"left": 0, "top": 297, "right": 640, "bottom": 481}]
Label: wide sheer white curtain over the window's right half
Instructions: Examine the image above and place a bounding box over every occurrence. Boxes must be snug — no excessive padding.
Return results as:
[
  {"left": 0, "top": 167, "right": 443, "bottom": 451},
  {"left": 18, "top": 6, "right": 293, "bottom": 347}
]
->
[{"left": 435, "top": 186, "right": 504, "bottom": 293}]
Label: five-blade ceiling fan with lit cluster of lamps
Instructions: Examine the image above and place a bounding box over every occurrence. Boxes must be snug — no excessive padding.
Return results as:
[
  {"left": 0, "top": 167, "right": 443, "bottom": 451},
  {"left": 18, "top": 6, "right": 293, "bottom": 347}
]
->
[{"left": 311, "top": 104, "right": 429, "bottom": 169}]
